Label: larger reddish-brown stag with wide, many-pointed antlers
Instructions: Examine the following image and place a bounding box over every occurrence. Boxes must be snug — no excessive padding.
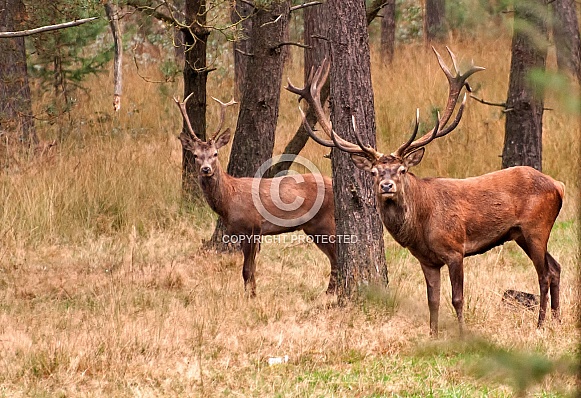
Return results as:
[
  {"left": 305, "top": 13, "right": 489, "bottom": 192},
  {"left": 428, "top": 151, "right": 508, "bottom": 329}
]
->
[{"left": 287, "top": 48, "right": 565, "bottom": 335}]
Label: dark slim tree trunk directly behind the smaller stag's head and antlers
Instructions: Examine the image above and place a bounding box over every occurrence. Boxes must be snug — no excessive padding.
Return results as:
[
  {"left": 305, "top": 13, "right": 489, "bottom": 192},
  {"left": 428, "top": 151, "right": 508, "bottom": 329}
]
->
[{"left": 182, "top": 0, "right": 210, "bottom": 201}]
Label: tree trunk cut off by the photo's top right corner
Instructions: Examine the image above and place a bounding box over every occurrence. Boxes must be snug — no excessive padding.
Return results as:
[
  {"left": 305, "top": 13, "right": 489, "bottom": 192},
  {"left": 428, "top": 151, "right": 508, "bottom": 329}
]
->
[{"left": 551, "top": 0, "right": 581, "bottom": 82}]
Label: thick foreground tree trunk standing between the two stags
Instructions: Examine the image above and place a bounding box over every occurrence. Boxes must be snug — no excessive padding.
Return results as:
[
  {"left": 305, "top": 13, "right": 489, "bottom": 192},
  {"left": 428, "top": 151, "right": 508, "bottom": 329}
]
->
[{"left": 328, "top": 0, "right": 388, "bottom": 300}]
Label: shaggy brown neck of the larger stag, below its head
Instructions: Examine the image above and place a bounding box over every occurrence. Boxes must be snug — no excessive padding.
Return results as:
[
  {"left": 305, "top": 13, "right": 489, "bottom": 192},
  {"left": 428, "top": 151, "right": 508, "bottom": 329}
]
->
[{"left": 378, "top": 173, "right": 424, "bottom": 247}]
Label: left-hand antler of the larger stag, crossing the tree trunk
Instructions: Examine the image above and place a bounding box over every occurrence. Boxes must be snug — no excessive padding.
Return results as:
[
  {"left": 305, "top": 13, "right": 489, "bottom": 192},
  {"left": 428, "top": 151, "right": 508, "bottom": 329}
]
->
[{"left": 285, "top": 58, "right": 383, "bottom": 159}]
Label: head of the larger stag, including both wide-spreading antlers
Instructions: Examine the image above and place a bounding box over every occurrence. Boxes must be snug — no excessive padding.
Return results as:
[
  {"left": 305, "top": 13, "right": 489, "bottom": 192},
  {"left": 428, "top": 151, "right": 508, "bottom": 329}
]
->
[{"left": 286, "top": 47, "right": 484, "bottom": 200}]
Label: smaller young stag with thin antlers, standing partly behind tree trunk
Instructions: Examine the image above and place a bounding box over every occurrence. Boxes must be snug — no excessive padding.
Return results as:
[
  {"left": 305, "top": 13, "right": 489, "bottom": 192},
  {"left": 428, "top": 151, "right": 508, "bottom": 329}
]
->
[{"left": 174, "top": 97, "right": 337, "bottom": 297}]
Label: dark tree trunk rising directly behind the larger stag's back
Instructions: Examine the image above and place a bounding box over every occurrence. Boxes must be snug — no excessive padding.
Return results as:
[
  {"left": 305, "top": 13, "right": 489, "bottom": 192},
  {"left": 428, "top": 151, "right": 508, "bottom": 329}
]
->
[{"left": 502, "top": 0, "right": 547, "bottom": 170}]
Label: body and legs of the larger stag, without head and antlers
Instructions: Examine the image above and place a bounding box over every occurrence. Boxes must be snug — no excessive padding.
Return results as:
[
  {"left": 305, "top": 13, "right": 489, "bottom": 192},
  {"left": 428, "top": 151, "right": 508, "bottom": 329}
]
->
[{"left": 377, "top": 166, "right": 564, "bottom": 334}]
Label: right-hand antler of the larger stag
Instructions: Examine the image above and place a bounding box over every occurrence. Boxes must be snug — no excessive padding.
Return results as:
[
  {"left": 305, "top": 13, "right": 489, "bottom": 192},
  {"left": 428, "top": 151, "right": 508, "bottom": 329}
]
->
[{"left": 392, "top": 47, "right": 485, "bottom": 158}]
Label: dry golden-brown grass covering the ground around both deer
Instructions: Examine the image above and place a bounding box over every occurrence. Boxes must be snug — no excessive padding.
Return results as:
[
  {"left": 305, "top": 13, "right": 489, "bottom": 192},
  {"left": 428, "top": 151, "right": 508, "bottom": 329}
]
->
[{"left": 0, "top": 28, "right": 580, "bottom": 397}]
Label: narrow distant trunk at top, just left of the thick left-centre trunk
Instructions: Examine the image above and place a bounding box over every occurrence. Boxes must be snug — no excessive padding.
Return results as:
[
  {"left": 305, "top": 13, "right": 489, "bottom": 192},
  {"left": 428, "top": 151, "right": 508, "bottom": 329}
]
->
[{"left": 230, "top": 1, "right": 253, "bottom": 101}]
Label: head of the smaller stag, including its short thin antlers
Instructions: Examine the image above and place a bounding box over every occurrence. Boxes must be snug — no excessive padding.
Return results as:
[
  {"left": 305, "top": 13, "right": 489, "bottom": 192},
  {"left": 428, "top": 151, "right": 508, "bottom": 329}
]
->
[{"left": 174, "top": 94, "right": 236, "bottom": 177}]
